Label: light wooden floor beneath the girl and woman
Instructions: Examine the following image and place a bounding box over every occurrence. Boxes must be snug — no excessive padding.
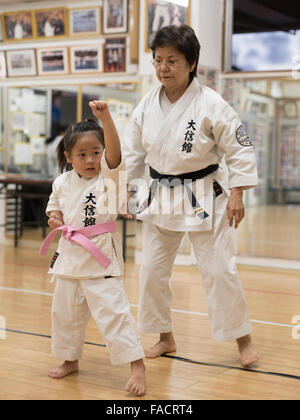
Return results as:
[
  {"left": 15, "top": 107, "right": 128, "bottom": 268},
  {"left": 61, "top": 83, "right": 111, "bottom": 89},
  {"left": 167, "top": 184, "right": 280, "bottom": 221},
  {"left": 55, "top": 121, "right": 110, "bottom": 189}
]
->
[{"left": 0, "top": 246, "right": 300, "bottom": 400}]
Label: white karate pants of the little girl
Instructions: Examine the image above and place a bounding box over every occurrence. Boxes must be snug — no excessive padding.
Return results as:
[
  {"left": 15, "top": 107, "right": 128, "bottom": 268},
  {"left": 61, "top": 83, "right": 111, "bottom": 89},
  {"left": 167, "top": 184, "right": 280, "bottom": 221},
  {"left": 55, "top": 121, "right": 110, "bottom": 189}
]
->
[{"left": 52, "top": 277, "right": 144, "bottom": 365}]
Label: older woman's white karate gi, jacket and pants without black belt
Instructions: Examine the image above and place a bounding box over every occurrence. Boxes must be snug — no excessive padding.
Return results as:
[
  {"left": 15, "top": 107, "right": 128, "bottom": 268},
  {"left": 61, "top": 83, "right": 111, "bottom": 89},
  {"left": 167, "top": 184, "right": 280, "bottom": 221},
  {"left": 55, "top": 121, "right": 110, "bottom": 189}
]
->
[{"left": 124, "top": 78, "right": 258, "bottom": 341}]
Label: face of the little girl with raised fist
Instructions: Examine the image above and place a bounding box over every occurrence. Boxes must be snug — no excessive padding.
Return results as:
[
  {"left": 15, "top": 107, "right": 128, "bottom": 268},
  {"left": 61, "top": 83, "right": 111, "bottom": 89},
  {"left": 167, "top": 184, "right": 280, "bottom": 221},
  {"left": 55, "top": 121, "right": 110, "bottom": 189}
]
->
[{"left": 65, "top": 133, "right": 104, "bottom": 179}]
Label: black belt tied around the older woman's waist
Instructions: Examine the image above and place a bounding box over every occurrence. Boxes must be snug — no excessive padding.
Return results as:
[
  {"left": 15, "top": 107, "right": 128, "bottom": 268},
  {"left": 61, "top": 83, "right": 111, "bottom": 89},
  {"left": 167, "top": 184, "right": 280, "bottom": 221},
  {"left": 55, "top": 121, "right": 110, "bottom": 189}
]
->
[{"left": 139, "top": 165, "right": 219, "bottom": 219}]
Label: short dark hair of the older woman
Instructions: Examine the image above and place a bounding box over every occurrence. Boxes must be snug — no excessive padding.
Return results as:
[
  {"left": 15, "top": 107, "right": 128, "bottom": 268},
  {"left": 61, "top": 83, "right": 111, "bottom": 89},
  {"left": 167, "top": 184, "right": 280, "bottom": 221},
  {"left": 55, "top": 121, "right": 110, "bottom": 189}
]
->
[{"left": 151, "top": 25, "right": 201, "bottom": 81}]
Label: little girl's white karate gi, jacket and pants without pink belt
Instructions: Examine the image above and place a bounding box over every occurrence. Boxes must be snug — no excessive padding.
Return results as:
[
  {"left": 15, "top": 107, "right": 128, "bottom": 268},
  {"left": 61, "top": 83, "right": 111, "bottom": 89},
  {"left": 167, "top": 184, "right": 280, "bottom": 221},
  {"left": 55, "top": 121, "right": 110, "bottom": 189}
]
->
[{"left": 46, "top": 154, "right": 144, "bottom": 365}]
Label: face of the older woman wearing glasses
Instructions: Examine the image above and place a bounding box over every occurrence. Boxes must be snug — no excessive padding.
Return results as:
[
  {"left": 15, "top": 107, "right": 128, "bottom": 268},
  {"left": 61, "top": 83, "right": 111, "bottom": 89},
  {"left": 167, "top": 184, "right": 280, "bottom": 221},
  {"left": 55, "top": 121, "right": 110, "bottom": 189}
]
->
[{"left": 153, "top": 46, "right": 195, "bottom": 90}]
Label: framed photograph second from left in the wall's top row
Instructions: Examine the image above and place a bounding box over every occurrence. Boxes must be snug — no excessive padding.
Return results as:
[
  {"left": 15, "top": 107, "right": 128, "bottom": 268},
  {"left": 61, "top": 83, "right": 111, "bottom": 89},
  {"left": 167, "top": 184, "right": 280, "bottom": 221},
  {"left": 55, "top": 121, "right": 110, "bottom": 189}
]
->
[{"left": 35, "top": 7, "right": 68, "bottom": 38}]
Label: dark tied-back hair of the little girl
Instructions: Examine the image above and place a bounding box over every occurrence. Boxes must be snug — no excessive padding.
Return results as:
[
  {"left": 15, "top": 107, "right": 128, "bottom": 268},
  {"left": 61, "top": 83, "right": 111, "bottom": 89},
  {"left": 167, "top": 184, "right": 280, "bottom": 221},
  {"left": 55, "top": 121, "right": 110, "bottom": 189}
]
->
[{"left": 56, "top": 118, "right": 105, "bottom": 173}]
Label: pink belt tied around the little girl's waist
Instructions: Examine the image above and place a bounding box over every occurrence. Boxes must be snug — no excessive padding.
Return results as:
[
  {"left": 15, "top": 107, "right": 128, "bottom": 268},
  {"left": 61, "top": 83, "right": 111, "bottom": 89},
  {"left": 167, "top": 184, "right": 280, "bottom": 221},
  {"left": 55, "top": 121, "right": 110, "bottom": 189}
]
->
[{"left": 40, "top": 222, "right": 117, "bottom": 268}]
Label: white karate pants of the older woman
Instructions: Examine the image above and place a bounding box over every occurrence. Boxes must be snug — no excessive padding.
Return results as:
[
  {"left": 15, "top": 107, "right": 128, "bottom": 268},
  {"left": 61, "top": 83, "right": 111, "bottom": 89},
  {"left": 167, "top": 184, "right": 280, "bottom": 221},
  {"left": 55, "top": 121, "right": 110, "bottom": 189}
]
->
[{"left": 138, "top": 193, "right": 251, "bottom": 341}]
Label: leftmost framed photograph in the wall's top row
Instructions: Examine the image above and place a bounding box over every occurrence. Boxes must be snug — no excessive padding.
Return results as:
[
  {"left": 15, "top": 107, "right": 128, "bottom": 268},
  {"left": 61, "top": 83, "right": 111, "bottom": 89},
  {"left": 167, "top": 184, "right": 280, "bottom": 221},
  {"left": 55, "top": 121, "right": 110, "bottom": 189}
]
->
[{"left": 1, "top": 10, "right": 34, "bottom": 41}]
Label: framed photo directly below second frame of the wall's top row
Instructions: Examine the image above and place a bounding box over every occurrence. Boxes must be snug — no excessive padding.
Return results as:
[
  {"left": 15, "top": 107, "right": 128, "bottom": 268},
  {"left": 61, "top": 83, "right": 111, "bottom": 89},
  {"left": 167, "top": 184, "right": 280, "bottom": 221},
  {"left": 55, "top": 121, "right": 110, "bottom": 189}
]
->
[{"left": 37, "top": 47, "right": 69, "bottom": 76}]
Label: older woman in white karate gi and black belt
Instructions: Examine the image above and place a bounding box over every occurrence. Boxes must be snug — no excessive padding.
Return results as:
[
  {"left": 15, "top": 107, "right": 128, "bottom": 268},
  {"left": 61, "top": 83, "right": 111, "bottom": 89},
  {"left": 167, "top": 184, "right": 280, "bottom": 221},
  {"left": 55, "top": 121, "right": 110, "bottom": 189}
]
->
[{"left": 124, "top": 25, "right": 258, "bottom": 367}]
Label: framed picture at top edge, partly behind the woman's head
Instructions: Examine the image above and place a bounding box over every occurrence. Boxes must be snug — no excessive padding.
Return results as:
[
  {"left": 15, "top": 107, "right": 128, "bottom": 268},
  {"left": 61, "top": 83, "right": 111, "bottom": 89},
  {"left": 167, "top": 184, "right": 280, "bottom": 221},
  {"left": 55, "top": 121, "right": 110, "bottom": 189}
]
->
[{"left": 145, "top": 0, "right": 191, "bottom": 52}]
